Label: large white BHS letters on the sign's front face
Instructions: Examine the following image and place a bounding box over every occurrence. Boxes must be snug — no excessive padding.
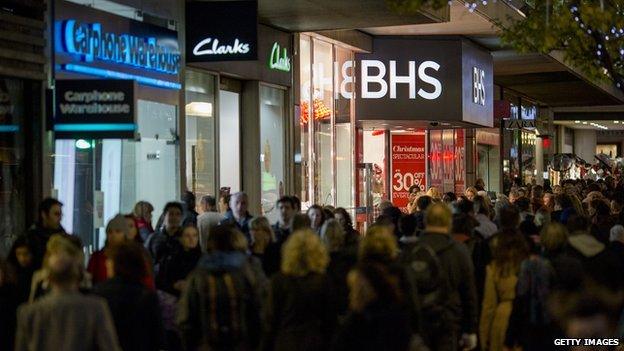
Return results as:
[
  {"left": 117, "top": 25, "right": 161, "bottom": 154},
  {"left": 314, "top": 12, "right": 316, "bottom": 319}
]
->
[{"left": 361, "top": 60, "right": 442, "bottom": 100}]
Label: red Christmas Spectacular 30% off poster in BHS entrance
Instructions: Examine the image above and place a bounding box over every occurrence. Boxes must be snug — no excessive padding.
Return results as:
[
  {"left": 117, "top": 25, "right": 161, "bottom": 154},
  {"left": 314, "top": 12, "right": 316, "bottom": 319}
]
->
[{"left": 390, "top": 130, "right": 427, "bottom": 211}]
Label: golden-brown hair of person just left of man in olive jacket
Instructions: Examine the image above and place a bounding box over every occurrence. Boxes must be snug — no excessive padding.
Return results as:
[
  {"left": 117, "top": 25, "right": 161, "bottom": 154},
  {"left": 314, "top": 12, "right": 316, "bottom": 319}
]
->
[{"left": 358, "top": 225, "right": 399, "bottom": 262}]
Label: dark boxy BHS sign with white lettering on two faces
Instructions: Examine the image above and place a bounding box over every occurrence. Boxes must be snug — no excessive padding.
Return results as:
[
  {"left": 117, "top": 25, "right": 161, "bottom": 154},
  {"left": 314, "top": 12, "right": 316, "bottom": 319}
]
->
[{"left": 356, "top": 37, "right": 493, "bottom": 127}]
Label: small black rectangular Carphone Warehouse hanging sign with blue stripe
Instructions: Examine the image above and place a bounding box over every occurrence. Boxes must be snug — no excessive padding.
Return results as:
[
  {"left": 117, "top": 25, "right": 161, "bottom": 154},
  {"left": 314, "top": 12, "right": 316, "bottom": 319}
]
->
[{"left": 54, "top": 79, "right": 136, "bottom": 139}]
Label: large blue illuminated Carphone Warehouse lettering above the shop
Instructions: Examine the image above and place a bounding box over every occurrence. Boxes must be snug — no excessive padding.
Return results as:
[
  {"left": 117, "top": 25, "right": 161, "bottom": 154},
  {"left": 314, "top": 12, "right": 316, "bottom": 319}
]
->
[{"left": 61, "top": 19, "right": 180, "bottom": 75}]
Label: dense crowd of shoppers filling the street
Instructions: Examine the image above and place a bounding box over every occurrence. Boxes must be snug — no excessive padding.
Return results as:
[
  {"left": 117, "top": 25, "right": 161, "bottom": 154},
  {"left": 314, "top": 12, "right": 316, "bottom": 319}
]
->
[{"left": 0, "top": 178, "right": 624, "bottom": 351}]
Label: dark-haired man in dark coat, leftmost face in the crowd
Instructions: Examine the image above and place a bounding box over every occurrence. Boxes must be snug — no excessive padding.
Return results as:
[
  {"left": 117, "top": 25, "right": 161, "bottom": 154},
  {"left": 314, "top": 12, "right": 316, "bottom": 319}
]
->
[{"left": 26, "top": 197, "right": 65, "bottom": 269}]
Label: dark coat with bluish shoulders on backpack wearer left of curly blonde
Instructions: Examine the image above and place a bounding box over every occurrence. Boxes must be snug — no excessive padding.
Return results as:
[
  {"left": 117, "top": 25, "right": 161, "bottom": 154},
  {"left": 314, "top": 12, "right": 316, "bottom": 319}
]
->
[{"left": 176, "top": 251, "right": 262, "bottom": 351}]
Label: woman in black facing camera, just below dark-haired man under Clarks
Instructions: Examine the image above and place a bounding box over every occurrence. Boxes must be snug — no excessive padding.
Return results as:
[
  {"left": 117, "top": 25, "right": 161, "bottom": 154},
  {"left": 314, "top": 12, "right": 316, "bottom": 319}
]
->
[{"left": 156, "top": 225, "right": 201, "bottom": 297}]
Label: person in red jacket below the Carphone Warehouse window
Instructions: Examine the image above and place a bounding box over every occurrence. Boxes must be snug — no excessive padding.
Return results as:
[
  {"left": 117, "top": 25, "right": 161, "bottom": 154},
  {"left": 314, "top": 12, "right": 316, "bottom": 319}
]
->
[{"left": 87, "top": 214, "right": 128, "bottom": 284}]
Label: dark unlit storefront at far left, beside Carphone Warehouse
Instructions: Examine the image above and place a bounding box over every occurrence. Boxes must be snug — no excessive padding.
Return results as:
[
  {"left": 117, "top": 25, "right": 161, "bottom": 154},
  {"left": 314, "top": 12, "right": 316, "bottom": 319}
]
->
[{"left": 0, "top": 2, "right": 47, "bottom": 257}]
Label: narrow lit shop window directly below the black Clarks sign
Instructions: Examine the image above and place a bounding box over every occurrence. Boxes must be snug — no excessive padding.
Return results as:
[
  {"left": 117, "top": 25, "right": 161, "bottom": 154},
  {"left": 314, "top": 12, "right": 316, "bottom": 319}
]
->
[{"left": 185, "top": 70, "right": 216, "bottom": 199}]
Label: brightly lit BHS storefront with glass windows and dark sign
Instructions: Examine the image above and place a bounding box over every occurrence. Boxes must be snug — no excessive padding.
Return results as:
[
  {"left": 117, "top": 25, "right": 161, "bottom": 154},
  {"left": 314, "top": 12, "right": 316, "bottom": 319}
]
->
[{"left": 295, "top": 34, "right": 493, "bottom": 221}]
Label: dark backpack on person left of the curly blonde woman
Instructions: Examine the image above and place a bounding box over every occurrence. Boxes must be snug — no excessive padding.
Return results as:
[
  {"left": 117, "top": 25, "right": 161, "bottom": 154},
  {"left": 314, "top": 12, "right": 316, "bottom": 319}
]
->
[{"left": 201, "top": 271, "right": 249, "bottom": 350}]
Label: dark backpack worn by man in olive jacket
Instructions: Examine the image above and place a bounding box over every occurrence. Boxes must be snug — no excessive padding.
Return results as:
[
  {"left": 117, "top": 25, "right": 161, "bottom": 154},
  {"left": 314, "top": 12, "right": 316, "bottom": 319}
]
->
[{"left": 403, "top": 241, "right": 452, "bottom": 334}]
